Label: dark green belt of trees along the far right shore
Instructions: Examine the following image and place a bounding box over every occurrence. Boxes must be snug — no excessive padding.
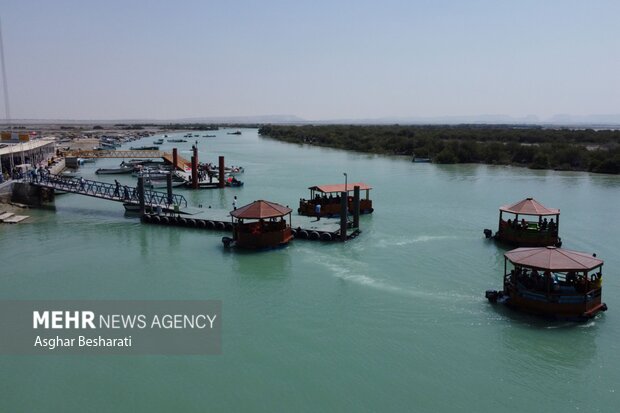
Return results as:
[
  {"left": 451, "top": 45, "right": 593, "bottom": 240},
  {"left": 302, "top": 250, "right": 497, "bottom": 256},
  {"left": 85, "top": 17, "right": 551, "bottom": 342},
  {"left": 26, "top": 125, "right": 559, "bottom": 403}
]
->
[{"left": 259, "top": 125, "right": 620, "bottom": 174}]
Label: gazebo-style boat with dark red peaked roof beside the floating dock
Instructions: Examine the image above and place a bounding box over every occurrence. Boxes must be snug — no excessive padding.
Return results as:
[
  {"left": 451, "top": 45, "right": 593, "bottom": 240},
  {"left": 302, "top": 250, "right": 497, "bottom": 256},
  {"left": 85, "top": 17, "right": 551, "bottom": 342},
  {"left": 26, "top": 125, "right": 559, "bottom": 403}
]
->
[{"left": 222, "top": 200, "right": 293, "bottom": 250}]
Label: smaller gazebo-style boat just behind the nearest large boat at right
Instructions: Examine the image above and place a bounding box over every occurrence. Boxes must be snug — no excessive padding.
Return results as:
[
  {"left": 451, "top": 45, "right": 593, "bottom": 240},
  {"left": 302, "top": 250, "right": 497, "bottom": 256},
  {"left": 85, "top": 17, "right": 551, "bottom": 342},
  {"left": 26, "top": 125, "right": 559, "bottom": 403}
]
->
[{"left": 484, "top": 198, "right": 562, "bottom": 247}]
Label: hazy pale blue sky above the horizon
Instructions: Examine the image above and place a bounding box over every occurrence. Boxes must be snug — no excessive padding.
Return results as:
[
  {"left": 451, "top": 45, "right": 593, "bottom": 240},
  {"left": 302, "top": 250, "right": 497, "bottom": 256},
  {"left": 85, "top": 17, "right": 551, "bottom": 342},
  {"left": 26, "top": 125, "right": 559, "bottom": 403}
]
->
[{"left": 0, "top": 0, "right": 620, "bottom": 119}]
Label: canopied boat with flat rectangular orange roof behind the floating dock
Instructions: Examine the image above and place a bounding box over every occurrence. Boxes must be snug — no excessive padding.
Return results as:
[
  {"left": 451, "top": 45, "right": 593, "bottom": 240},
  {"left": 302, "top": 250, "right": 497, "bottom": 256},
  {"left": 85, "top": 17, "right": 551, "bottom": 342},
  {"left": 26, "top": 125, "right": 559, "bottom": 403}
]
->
[{"left": 297, "top": 182, "right": 374, "bottom": 217}]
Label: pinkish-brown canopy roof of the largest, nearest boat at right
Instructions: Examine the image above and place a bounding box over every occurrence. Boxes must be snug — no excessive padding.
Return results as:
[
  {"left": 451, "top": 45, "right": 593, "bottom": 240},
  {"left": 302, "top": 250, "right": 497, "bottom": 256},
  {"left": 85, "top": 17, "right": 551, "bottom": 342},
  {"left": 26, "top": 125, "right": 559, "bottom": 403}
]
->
[{"left": 504, "top": 247, "right": 603, "bottom": 271}]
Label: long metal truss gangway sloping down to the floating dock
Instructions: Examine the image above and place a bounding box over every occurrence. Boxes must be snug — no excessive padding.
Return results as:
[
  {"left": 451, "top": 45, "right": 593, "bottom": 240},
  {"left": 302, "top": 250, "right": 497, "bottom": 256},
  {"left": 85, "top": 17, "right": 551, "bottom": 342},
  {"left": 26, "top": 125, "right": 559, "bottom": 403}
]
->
[{"left": 26, "top": 174, "right": 187, "bottom": 207}]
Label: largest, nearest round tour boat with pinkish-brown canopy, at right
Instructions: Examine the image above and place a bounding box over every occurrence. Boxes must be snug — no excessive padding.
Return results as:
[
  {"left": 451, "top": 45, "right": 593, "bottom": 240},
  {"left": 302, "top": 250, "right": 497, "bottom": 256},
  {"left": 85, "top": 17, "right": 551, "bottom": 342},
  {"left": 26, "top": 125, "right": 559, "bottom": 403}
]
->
[{"left": 485, "top": 247, "right": 607, "bottom": 320}]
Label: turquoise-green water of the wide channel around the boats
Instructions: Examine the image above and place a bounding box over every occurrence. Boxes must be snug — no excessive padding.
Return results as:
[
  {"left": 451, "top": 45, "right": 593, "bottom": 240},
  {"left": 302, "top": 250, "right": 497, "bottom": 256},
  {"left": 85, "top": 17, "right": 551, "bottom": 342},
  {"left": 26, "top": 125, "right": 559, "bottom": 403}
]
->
[{"left": 0, "top": 129, "right": 620, "bottom": 412}]
